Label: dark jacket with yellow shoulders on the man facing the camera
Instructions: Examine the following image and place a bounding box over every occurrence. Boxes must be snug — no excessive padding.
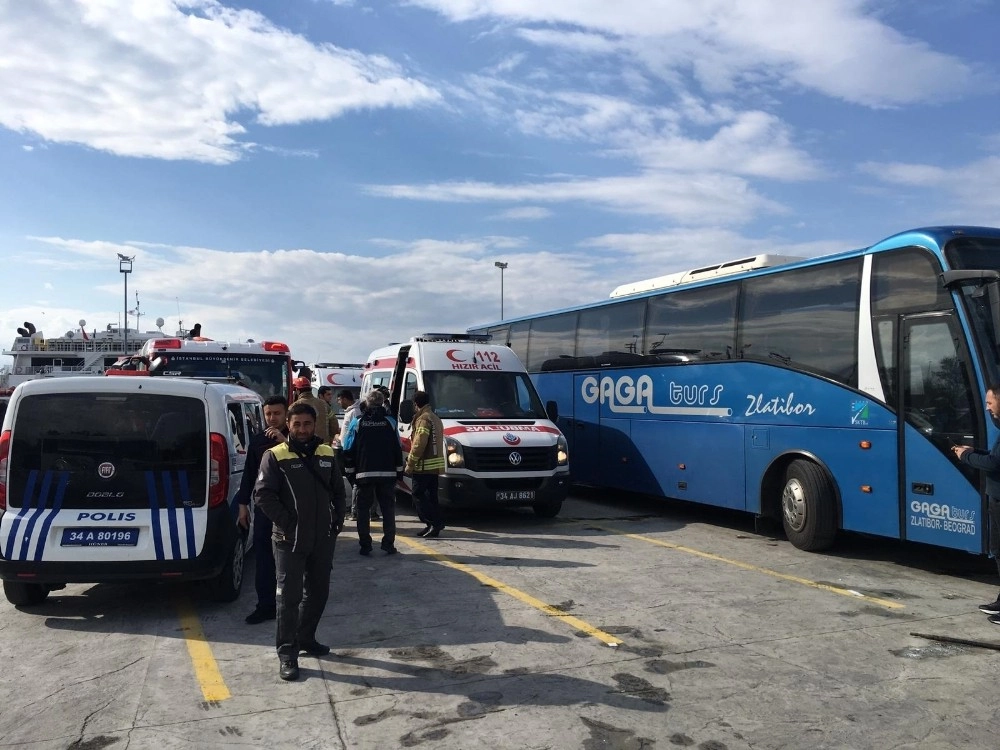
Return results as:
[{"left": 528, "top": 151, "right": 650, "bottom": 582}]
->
[{"left": 254, "top": 437, "right": 346, "bottom": 554}]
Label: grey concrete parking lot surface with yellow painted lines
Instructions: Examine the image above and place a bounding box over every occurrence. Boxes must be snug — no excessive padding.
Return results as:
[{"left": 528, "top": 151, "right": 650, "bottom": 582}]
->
[{"left": 0, "top": 492, "right": 1000, "bottom": 750}]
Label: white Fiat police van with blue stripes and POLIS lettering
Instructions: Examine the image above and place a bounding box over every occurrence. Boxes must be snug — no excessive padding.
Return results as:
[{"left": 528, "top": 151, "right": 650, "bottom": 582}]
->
[{"left": 0, "top": 376, "right": 262, "bottom": 605}]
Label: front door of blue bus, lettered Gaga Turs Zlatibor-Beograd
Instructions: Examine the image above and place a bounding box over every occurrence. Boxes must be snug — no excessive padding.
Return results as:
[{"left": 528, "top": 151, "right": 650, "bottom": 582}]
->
[{"left": 896, "top": 312, "right": 986, "bottom": 553}]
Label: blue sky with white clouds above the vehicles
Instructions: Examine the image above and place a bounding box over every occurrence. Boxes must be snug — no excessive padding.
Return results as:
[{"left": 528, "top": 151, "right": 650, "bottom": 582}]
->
[{"left": 0, "top": 0, "right": 1000, "bottom": 364}]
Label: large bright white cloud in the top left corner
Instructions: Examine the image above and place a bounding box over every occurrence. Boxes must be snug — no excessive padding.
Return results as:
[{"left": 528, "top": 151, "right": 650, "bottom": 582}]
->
[{"left": 0, "top": 0, "right": 439, "bottom": 164}]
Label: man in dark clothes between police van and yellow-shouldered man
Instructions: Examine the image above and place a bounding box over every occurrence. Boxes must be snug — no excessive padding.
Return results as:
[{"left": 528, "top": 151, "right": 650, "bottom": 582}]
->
[{"left": 236, "top": 395, "right": 288, "bottom": 625}]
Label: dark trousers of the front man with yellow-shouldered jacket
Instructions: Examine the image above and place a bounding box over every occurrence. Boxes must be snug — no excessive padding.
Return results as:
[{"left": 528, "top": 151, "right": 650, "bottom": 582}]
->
[{"left": 272, "top": 536, "right": 337, "bottom": 659}]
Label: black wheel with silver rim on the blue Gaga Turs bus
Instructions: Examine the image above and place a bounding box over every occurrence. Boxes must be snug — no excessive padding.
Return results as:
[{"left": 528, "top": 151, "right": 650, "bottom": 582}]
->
[{"left": 781, "top": 459, "right": 837, "bottom": 551}]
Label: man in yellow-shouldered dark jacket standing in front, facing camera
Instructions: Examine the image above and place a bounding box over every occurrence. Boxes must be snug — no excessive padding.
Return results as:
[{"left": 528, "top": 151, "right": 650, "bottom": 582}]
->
[{"left": 254, "top": 403, "right": 345, "bottom": 680}]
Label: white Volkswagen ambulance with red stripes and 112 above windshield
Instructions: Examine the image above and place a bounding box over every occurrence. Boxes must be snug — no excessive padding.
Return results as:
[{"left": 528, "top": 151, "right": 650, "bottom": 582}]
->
[{"left": 361, "top": 333, "right": 569, "bottom": 518}]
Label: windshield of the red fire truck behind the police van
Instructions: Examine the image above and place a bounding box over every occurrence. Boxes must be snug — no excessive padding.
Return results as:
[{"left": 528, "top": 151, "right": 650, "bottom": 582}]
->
[{"left": 150, "top": 352, "right": 289, "bottom": 398}]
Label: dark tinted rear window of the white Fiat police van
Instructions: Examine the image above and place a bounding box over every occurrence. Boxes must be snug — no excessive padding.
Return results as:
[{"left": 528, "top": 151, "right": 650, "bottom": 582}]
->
[{"left": 7, "top": 393, "right": 208, "bottom": 510}]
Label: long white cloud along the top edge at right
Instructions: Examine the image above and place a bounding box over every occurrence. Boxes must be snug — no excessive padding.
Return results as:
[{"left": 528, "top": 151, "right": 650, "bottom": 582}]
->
[{"left": 409, "top": 0, "right": 976, "bottom": 107}]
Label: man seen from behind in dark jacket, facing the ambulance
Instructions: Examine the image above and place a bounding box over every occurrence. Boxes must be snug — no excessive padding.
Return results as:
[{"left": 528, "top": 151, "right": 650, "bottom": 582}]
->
[{"left": 344, "top": 390, "right": 403, "bottom": 555}]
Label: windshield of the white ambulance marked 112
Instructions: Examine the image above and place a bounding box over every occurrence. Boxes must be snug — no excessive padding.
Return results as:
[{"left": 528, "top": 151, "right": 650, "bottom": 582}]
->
[{"left": 424, "top": 371, "right": 546, "bottom": 419}]
